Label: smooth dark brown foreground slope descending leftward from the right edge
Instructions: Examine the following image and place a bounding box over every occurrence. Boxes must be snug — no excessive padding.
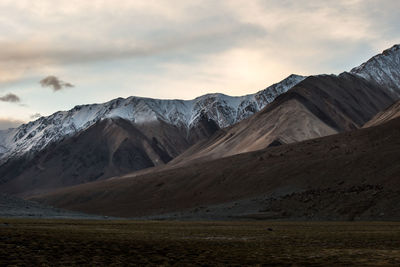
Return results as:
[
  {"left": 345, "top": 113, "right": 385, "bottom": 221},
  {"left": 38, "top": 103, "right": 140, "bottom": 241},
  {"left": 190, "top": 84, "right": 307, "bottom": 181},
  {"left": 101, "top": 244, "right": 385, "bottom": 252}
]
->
[{"left": 35, "top": 119, "right": 400, "bottom": 218}]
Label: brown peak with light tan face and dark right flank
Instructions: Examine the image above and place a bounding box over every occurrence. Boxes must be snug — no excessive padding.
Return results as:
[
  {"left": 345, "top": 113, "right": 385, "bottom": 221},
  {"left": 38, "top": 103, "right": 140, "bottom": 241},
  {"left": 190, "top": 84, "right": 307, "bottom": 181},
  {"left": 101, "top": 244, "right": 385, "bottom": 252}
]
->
[{"left": 171, "top": 73, "right": 394, "bottom": 164}]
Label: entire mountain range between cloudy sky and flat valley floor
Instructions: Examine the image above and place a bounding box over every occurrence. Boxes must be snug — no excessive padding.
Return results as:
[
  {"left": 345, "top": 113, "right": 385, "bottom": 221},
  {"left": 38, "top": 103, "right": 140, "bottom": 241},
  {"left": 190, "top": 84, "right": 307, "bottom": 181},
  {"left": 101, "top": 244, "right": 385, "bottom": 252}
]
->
[{"left": 0, "top": 45, "right": 400, "bottom": 219}]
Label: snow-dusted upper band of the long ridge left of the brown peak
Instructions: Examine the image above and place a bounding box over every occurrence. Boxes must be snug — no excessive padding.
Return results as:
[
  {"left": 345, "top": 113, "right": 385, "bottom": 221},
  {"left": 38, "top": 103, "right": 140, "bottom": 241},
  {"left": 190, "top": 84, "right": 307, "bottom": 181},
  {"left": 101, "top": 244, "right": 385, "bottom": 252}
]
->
[{"left": 0, "top": 75, "right": 305, "bottom": 163}]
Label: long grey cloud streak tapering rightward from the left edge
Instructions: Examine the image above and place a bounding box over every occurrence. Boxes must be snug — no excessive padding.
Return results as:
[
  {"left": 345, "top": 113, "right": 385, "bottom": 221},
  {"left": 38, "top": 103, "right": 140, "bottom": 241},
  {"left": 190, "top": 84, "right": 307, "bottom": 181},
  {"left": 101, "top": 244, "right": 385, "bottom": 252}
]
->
[{"left": 0, "top": 14, "right": 266, "bottom": 66}]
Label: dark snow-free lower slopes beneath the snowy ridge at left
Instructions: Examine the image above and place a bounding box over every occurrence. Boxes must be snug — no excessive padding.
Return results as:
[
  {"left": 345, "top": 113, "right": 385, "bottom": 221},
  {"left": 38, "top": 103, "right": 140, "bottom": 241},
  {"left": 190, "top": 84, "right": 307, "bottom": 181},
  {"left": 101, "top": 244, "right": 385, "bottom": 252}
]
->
[{"left": 0, "top": 119, "right": 219, "bottom": 195}]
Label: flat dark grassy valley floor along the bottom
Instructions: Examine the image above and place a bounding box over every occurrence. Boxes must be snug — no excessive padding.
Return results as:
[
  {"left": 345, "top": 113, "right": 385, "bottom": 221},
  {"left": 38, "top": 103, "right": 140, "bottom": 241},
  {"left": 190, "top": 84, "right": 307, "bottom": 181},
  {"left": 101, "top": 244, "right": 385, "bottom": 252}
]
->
[{"left": 0, "top": 218, "right": 400, "bottom": 266}]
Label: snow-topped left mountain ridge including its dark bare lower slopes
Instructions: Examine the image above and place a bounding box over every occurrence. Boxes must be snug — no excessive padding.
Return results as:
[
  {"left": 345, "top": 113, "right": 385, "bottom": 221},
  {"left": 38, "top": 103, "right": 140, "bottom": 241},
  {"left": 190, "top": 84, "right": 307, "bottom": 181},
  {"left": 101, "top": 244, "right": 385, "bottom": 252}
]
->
[{"left": 0, "top": 75, "right": 305, "bottom": 194}]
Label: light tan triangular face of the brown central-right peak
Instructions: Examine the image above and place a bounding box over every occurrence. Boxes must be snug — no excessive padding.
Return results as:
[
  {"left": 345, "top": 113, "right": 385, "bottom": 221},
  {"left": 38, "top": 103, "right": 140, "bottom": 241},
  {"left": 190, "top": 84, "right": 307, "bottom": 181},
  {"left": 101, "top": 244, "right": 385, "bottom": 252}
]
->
[{"left": 171, "top": 99, "right": 338, "bottom": 164}]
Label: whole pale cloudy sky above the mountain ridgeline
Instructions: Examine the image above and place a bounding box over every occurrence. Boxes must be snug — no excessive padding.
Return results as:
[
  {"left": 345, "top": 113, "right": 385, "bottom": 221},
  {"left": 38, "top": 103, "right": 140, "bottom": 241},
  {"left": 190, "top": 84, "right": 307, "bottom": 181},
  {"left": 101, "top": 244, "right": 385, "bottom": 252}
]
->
[{"left": 0, "top": 0, "right": 400, "bottom": 129}]
